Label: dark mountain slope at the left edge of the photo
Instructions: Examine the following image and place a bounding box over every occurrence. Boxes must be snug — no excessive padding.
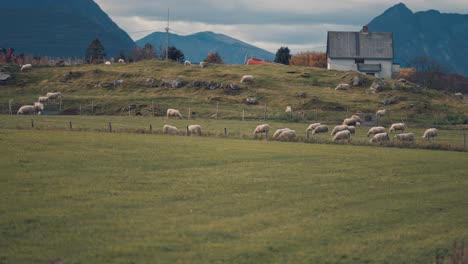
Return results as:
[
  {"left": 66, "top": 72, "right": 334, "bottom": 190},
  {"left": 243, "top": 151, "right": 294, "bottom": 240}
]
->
[{"left": 0, "top": 0, "right": 135, "bottom": 57}]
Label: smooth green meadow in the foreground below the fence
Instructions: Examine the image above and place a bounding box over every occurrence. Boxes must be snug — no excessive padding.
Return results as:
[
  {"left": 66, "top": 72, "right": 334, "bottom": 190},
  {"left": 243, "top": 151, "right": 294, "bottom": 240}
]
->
[{"left": 0, "top": 129, "right": 468, "bottom": 263}]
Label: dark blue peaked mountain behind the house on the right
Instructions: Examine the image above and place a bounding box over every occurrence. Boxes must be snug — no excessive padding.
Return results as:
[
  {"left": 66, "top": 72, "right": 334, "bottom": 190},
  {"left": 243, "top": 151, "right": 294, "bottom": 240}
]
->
[{"left": 368, "top": 3, "right": 468, "bottom": 76}]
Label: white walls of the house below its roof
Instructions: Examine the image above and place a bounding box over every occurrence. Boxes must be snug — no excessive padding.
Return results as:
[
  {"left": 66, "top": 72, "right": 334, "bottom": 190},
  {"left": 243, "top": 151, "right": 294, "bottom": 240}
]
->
[{"left": 328, "top": 58, "right": 393, "bottom": 79}]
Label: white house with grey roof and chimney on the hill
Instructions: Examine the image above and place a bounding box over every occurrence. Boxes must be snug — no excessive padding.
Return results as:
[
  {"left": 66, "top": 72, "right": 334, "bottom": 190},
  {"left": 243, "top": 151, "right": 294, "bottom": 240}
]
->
[{"left": 327, "top": 26, "right": 400, "bottom": 79}]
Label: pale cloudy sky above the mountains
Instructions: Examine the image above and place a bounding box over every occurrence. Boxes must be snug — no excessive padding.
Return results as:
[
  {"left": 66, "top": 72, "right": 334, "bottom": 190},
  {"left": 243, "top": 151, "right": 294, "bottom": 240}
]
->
[{"left": 95, "top": 0, "right": 468, "bottom": 53}]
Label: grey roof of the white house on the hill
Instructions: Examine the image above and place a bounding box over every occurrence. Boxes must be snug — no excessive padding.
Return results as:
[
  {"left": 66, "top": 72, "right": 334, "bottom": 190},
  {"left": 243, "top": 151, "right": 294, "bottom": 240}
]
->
[{"left": 327, "top": 31, "right": 393, "bottom": 59}]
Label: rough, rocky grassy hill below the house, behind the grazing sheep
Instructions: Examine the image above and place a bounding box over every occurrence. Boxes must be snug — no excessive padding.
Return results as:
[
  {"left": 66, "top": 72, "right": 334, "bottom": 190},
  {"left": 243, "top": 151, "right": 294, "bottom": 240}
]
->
[{"left": 0, "top": 60, "right": 468, "bottom": 126}]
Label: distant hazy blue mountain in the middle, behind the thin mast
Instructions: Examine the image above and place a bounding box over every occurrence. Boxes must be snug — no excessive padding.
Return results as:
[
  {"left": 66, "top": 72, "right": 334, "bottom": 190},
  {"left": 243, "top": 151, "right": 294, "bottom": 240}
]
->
[{"left": 136, "top": 32, "right": 275, "bottom": 64}]
